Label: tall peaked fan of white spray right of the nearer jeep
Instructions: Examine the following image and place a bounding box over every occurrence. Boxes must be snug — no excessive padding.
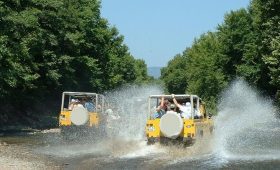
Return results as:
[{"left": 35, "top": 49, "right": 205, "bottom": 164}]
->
[{"left": 214, "top": 79, "right": 280, "bottom": 160}]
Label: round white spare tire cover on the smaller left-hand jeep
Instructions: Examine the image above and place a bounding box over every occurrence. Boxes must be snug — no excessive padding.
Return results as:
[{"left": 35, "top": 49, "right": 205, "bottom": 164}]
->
[{"left": 70, "top": 106, "right": 89, "bottom": 125}]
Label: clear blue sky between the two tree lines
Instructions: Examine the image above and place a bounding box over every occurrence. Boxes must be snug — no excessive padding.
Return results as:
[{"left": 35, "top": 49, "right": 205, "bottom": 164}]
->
[{"left": 101, "top": 0, "right": 250, "bottom": 67}]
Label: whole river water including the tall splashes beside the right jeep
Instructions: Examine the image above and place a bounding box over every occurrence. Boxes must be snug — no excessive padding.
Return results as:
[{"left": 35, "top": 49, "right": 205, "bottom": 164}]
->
[{"left": 0, "top": 80, "right": 280, "bottom": 169}]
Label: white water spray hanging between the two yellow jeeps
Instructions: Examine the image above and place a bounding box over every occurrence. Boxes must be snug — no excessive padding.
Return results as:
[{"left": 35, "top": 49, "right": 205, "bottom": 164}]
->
[{"left": 106, "top": 85, "right": 163, "bottom": 140}]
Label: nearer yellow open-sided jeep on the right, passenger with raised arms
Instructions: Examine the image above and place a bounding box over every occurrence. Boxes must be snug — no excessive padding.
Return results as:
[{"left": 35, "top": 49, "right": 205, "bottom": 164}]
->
[{"left": 146, "top": 94, "right": 213, "bottom": 146}]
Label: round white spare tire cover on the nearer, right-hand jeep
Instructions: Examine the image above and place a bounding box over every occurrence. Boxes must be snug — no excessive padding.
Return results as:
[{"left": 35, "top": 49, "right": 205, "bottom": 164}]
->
[{"left": 159, "top": 113, "right": 184, "bottom": 139}]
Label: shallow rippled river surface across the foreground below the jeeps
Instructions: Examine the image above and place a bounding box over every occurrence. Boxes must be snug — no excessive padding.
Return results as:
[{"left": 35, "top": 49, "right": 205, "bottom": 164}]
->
[{"left": 0, "top": 122, "right": 280, "bottom": 169}]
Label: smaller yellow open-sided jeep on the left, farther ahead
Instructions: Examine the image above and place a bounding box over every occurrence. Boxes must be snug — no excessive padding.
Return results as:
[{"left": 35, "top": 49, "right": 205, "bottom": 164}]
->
[{"left": 59, "top": 92, "right": 104, "bottom": 135}]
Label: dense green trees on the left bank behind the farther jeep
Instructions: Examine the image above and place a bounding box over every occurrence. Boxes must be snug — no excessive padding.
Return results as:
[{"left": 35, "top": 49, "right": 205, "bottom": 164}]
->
[{"left": 0, "top": 0, "right": 151, "bottom": 126}]
